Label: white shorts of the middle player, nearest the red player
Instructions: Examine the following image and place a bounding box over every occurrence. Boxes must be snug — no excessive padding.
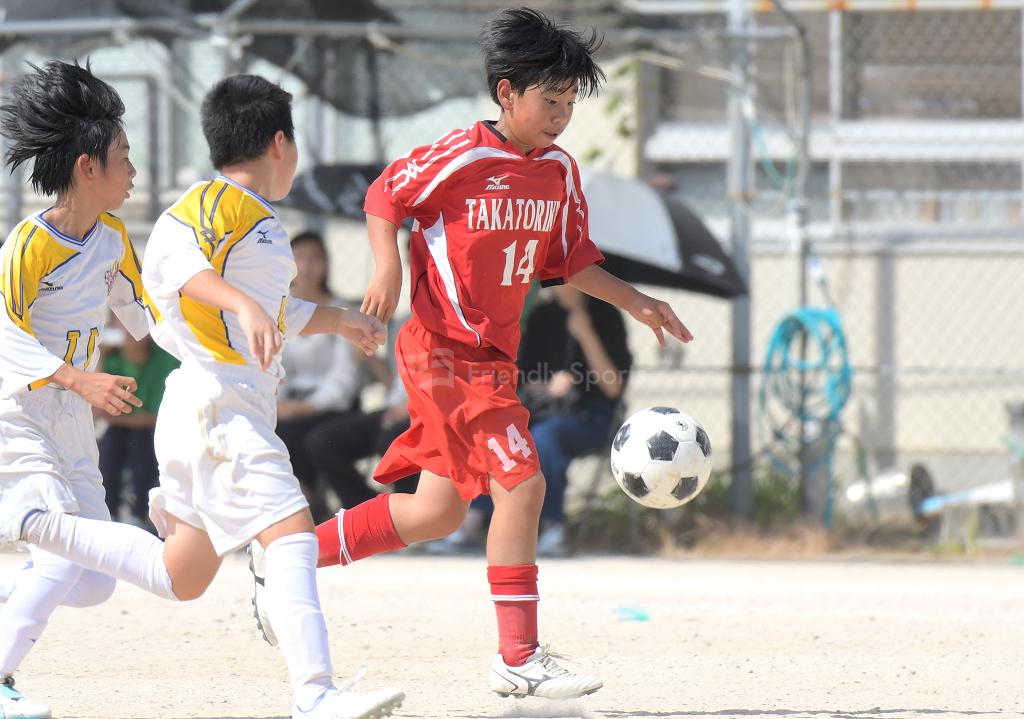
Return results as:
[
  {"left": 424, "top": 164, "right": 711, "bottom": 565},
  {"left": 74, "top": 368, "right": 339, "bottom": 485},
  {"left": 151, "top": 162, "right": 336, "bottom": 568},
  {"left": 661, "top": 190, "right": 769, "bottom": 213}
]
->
[{"left": 150, "top": 363, "right": 308, "bottom": 555}]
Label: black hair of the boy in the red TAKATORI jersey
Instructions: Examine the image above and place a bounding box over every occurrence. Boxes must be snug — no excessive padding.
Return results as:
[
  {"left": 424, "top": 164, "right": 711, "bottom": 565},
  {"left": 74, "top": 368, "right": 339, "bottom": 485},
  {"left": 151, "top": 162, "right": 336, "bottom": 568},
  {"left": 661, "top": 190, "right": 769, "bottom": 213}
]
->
[{"left": 480, "top": 7, "right": 604, "bottom": 102}]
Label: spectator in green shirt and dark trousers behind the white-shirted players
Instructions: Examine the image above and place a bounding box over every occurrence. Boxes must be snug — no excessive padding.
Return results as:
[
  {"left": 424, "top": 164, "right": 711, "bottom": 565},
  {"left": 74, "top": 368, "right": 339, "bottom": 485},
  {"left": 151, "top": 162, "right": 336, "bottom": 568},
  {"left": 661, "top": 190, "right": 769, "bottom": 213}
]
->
[{"left": 98, "top": 320, "right": 178, "bottom": 526}]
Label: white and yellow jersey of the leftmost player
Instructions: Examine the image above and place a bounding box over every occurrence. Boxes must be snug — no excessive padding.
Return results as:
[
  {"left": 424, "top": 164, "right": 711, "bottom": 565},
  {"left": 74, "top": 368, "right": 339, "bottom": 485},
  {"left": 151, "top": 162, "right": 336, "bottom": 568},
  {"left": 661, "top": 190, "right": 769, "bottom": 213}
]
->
[{"left": 0, "top": 210, "right": 152, "bottom": 397}]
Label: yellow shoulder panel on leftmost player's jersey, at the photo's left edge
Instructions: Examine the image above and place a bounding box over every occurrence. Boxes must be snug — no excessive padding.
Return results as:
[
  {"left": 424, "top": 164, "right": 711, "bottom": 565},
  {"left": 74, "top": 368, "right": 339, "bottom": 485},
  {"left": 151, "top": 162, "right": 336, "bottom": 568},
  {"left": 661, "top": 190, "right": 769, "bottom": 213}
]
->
[{"left": 0, "top": 219, "right": 79, "bottom": 336}]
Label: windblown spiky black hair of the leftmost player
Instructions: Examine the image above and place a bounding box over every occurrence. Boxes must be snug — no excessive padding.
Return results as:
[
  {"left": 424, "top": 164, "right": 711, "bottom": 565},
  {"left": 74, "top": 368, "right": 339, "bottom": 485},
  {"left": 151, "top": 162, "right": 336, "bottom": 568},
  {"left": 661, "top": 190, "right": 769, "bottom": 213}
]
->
[{"left": 0, "top": 60, "right": 125, "bottom": 195}]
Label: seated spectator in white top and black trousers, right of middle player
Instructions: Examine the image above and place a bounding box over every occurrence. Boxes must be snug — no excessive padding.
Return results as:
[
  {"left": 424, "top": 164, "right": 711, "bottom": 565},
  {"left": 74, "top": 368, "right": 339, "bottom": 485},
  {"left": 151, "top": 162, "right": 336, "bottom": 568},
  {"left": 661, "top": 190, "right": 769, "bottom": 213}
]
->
[{"left": 278, "top": 231, "right": 390, "bottom": 521}]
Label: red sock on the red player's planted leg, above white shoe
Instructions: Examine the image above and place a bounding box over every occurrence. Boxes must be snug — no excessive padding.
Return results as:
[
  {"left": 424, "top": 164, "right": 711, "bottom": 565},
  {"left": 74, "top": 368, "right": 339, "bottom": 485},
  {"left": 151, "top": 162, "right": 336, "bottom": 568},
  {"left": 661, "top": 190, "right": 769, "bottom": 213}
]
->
[{"left": 487, "top": 564, "right": 541, "bottom": 667}]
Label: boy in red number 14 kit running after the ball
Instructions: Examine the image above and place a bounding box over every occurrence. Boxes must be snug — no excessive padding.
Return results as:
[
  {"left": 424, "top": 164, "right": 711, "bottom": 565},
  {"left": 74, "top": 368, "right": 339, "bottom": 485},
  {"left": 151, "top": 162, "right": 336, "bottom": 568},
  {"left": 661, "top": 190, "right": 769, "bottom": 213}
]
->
[{"left": 253, "top": 8, "right": 692, "bottom": 699}]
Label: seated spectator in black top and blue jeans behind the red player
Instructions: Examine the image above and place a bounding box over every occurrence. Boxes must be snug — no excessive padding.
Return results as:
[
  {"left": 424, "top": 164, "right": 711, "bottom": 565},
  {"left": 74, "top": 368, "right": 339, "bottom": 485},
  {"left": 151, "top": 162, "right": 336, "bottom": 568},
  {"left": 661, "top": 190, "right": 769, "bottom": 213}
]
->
[{"left": 434, "top": 285, "right": 633, "bottom": 556}]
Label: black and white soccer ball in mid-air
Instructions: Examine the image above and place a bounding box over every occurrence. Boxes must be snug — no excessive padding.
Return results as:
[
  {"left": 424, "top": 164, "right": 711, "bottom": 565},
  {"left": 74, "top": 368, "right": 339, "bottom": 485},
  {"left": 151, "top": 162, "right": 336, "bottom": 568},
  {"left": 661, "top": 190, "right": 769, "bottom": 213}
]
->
[{"left": 611, "top": 407, "right": 711, "bottom": 509}]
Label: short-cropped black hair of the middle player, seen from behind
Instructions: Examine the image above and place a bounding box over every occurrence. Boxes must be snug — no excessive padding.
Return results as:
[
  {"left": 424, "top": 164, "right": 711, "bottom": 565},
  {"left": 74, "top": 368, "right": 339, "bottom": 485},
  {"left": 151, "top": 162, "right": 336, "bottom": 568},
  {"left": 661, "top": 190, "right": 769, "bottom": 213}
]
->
[{"left": 200, "top": 75, "right": 295, "bottom": 170}]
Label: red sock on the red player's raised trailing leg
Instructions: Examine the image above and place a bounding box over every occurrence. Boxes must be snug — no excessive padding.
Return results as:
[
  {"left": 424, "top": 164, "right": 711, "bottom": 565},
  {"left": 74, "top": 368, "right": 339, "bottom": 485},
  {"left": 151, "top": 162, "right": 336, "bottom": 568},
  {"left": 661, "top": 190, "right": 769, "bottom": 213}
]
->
[{"left": 316, "top": 494, "right": 406, "bottom": 566}]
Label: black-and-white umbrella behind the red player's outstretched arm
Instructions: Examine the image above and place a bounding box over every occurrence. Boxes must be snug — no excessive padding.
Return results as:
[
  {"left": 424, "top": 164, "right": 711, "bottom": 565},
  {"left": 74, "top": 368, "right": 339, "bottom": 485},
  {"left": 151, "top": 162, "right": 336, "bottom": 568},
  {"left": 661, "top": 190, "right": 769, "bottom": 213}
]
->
[{"left": 583, "top": 172, "right": 746, "bottom": 298}]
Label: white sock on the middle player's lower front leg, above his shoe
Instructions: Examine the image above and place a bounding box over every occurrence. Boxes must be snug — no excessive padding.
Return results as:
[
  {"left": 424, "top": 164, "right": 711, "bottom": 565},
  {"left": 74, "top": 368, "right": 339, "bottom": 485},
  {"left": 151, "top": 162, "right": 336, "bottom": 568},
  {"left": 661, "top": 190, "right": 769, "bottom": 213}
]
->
[{"left": 264, "top": 532, "right": 334, "bottom": 710}]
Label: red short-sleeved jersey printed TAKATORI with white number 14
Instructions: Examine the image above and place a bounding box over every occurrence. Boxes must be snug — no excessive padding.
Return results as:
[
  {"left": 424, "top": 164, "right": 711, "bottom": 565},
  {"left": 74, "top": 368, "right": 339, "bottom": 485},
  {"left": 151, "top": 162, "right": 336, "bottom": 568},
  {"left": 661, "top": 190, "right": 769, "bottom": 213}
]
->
[{"left": 365, "top": 122, "right": 604, "bottom": 360}]
